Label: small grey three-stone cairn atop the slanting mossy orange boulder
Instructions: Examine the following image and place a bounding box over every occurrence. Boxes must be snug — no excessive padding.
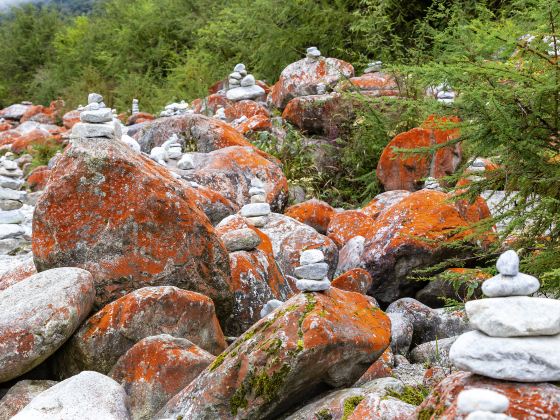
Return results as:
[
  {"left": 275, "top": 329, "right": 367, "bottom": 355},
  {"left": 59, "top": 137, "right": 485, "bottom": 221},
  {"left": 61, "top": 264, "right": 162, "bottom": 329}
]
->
[{"left": 295, "top": 249, "right": 331, "bottom": 292}]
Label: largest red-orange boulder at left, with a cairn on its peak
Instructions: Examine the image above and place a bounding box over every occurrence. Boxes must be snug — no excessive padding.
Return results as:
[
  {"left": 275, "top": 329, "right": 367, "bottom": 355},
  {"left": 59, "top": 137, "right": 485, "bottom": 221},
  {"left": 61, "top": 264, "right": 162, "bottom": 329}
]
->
[{"left": 32, "top": 138, "right": 233, "bottom": 317}]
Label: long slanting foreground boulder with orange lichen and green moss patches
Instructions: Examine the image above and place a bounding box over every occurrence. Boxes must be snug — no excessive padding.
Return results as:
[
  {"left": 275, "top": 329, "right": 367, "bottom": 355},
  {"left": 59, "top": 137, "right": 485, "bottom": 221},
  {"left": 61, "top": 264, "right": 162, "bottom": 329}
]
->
[{"left": 158, "top": 288, "right": 390, "bottom": 420}]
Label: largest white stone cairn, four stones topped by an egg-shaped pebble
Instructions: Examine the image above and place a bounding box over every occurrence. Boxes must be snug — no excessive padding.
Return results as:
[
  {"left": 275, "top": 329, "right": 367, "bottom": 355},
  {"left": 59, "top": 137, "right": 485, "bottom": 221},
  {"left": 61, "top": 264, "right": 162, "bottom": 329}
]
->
[{"left": 449, "top": 251, "right": 560, "bottom": 382}]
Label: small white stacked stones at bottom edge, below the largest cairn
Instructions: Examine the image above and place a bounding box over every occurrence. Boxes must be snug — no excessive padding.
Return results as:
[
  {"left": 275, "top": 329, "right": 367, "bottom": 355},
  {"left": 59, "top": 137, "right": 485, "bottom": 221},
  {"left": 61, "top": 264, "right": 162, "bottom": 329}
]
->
[{"left": 457, "top": 388, "right": 513, "bottom": 420}]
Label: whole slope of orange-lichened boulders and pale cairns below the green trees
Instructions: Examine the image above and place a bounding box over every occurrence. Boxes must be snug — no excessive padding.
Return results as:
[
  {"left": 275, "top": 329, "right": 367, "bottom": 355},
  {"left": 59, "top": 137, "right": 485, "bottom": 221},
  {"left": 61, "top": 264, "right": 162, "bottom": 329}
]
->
[{"left": 0, "top": 48, "right": 560, "bottom": 420}]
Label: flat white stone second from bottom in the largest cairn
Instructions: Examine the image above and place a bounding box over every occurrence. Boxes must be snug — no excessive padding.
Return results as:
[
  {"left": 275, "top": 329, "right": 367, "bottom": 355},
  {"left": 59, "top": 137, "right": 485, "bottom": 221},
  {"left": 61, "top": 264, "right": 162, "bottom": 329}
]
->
[{"left": 465, "top": 296, "right": 560, "bottom": 336}]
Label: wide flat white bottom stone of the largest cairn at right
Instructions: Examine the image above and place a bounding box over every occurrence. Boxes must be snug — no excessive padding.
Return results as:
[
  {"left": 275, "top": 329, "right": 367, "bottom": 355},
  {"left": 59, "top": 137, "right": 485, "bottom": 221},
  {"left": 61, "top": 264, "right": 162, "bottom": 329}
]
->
[{"left": 449, "top": 331, "right": 560, "bottom": 382}]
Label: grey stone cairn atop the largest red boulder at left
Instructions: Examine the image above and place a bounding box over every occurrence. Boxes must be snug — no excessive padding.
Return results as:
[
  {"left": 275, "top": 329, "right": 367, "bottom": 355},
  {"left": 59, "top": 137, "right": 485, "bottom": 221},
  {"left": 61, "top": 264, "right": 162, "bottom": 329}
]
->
[{"left": 70, "top": 93, "right": 122, "bottom": 139}]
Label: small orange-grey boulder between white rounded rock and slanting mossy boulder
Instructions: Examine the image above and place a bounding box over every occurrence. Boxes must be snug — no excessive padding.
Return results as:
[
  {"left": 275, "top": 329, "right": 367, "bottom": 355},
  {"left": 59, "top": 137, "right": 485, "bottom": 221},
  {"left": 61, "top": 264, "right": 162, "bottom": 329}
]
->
[{"left": 109, "top": 334, "right": 214, "bottom": 420}]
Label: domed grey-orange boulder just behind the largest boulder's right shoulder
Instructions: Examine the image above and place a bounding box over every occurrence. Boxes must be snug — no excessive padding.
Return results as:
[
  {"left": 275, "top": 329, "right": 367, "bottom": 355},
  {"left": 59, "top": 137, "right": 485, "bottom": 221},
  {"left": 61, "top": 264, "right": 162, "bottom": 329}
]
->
[{"left": 181, "top": 146, "right": 288, "bottom": 211}]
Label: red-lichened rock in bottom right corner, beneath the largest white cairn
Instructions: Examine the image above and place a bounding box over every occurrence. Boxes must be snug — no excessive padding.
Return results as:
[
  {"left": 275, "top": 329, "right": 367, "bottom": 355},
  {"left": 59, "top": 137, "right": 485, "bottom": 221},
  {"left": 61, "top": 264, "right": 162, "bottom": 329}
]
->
[{"left": 415, "top": 372, "right": 560, "bottom": 420}]
